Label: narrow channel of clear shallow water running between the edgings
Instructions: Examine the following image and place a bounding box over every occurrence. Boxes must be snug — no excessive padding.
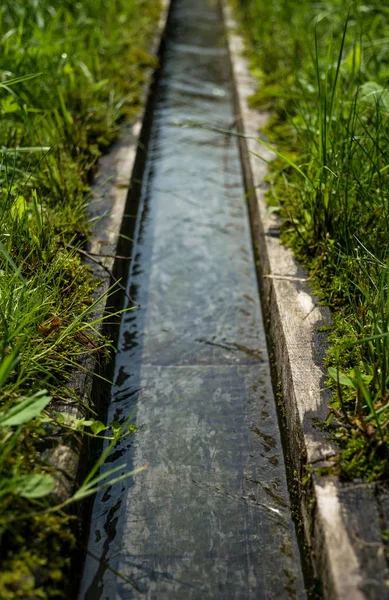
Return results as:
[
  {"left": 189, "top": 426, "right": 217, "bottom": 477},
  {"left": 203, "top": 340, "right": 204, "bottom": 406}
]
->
[{"left": 79, "top": 0, "right": 305, "bottom": 600}]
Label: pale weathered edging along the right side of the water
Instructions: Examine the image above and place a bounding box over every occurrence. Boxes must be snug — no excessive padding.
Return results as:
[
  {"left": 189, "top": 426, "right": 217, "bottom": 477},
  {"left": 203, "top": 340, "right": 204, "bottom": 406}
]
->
[{"left": 221, "top": 0, "right": 388, "bottom": 600}]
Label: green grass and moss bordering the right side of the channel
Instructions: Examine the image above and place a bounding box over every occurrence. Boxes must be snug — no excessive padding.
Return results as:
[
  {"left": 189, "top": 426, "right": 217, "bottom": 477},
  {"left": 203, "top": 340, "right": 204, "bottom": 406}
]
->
[{"left": 234, "top": 0, "right": 389, "bottom": 479}]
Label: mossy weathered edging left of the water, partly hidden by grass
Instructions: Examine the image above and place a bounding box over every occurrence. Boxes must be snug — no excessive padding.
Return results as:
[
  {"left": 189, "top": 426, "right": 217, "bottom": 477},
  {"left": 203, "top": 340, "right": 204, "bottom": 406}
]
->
[{"left": 44, "top": 0, "right": 172, "bottom": 503}]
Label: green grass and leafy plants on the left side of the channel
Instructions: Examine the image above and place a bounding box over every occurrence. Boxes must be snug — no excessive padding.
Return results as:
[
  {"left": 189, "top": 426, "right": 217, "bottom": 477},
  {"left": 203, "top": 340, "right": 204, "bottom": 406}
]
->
[{"left": 0, "top": 0, "right": 160, "bottom": 600}]
